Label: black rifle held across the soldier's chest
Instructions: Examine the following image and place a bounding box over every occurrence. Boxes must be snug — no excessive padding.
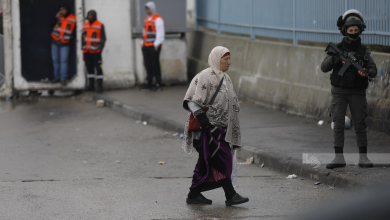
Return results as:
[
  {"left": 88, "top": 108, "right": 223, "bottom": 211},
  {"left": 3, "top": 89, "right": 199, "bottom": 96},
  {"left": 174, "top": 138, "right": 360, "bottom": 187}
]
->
[{"left": 325, "top": 42, "right": 373, "bottom": 82}]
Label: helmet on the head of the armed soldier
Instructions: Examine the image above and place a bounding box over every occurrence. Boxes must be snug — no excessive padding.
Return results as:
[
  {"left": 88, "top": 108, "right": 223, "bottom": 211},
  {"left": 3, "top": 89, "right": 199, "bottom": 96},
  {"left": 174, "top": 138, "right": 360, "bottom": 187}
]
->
[{"left": 337, "top": 9, "right": 367, "bottom": 36}]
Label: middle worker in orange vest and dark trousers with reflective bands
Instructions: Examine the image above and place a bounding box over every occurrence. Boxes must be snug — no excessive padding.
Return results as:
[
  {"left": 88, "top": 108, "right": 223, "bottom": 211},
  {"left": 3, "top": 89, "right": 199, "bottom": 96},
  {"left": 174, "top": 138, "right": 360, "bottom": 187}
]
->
[{"left": 81, "top": 10, "right": 106, "bottom": 92}]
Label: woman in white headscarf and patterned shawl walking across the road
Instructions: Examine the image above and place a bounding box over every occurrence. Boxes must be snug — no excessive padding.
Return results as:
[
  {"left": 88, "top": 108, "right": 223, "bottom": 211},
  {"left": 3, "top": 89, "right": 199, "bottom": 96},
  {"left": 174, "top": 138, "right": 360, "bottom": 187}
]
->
[{"left": 183, "top": 46, "right": 249, "bottom": 206}]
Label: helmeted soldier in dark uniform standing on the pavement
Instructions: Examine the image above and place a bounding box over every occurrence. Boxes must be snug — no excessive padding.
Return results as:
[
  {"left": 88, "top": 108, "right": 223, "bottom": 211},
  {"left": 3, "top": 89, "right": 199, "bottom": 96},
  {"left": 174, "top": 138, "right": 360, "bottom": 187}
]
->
[{"left": 321, "top": 9, "right": 377, "bottom": 169}]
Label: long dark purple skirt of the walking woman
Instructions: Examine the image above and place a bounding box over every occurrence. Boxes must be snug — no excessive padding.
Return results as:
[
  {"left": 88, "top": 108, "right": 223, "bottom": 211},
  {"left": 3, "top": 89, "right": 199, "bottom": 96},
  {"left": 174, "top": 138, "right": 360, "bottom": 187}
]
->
[{"left": 190, "top": 126, "right": 233, "bottom": 192}]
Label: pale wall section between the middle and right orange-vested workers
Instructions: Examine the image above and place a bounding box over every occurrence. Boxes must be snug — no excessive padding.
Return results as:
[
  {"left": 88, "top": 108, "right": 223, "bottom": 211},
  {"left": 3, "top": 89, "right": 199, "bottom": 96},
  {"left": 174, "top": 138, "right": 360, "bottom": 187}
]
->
[{"left": 84, "top": 0, "right": 135, "bottom": 88}]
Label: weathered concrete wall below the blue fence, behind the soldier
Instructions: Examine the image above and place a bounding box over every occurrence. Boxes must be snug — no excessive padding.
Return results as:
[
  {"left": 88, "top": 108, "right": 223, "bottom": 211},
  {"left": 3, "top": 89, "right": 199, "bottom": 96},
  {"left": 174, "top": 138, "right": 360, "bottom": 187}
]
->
[{"left": 187, "top": 31, "right": 390, "bottom": 134}]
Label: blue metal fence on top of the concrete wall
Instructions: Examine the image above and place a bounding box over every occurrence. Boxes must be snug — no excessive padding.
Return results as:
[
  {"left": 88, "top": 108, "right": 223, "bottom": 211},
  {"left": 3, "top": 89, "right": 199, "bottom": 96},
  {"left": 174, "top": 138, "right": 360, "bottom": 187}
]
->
[{"left": 196, "top": 0, "right": 390, "bottom": 46}]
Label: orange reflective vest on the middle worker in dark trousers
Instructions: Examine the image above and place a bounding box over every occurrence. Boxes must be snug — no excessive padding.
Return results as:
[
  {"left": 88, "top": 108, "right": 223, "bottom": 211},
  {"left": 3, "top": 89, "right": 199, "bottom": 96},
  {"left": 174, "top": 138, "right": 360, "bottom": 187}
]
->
[{"left": 82, "top": 20, "right": 103, "bottom": 53}]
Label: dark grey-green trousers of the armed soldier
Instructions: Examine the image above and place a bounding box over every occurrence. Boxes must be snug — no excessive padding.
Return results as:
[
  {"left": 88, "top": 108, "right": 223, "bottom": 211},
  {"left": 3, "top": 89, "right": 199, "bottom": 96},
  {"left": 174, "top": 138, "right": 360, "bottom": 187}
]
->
[{"left": 330, "top": 94, "right": 367, "bottom": 148}]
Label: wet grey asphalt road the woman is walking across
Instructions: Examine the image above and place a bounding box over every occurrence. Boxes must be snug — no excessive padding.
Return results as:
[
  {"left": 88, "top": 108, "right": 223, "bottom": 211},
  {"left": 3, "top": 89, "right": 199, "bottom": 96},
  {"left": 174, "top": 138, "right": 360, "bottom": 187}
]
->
[{"left": 0, "top": 97, "right": 347, "bottom": 219}]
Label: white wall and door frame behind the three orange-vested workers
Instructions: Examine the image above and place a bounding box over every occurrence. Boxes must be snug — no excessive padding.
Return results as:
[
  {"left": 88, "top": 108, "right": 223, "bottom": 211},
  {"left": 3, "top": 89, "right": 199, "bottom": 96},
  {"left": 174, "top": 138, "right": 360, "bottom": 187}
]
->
[{"left": 0, "top": 0, "right": 187, "bottom": 97}]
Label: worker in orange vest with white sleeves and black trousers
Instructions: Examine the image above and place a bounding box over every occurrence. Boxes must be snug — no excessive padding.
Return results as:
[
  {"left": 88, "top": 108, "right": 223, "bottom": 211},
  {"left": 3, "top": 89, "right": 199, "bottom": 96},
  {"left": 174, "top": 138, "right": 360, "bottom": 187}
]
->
[{"left": 142, "top": 2, "right": 165, "bottom": 91}]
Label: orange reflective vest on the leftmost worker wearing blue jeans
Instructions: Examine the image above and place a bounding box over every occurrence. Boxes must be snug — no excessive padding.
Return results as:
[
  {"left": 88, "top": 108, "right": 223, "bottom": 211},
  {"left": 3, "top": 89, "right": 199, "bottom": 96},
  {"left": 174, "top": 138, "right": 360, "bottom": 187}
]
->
[{"left": 51, "top": 14, "right": 76, "bottom": 44}]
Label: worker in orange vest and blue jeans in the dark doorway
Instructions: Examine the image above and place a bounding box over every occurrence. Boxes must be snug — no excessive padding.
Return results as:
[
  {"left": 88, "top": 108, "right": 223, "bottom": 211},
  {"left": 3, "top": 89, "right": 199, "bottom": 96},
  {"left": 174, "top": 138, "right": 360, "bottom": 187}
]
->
[{"left": 51, "top": 4, "right": 76, "bottom": 85}]
